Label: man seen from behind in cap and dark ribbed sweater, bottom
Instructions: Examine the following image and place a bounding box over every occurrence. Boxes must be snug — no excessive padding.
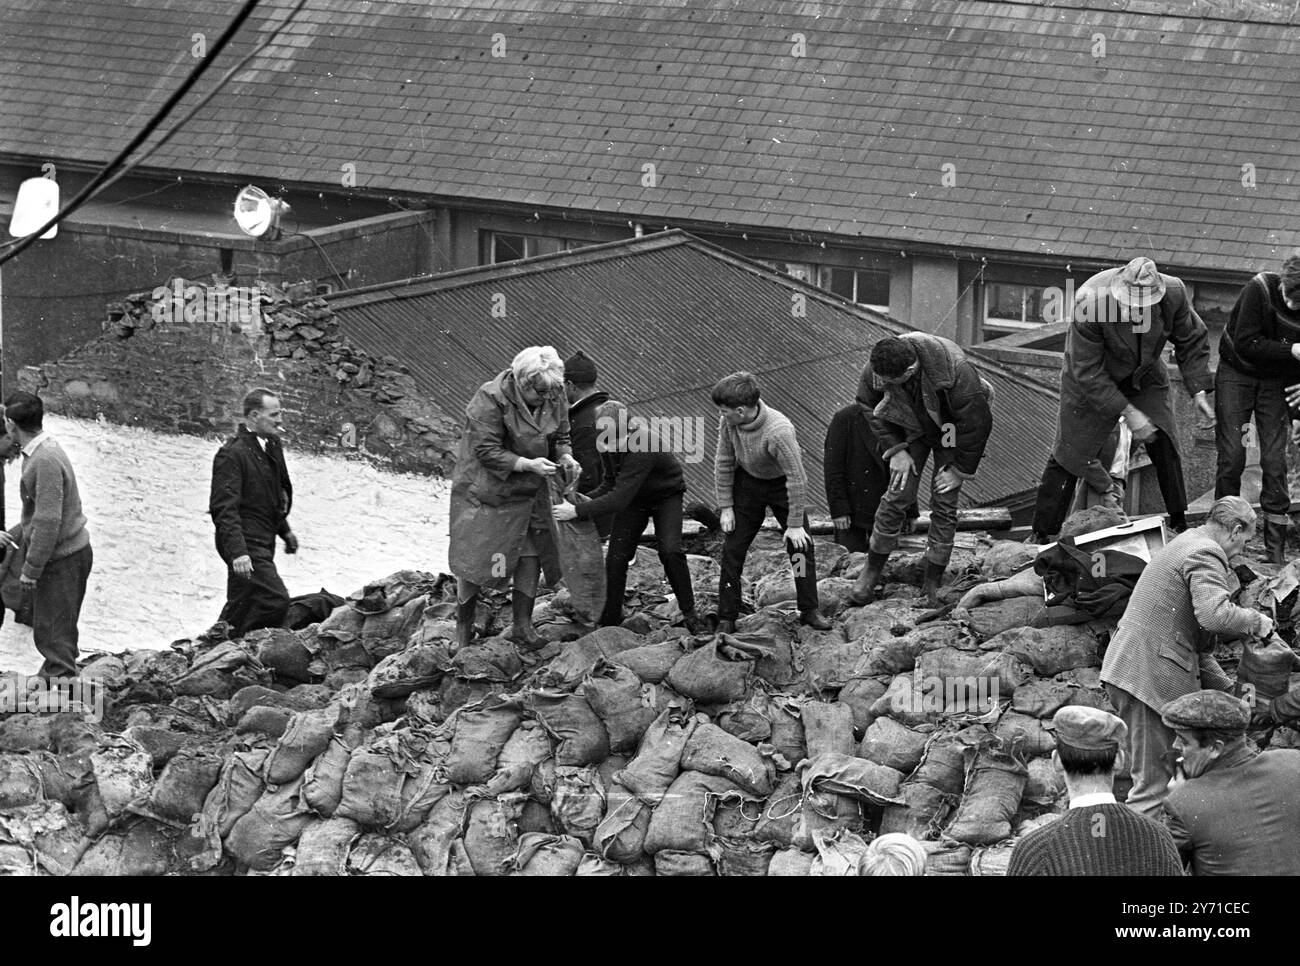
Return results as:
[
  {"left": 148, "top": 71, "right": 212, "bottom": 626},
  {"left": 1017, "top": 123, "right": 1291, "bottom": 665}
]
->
[{"left": 1006, "top": 705, "right": 1183, "bottom": 875}]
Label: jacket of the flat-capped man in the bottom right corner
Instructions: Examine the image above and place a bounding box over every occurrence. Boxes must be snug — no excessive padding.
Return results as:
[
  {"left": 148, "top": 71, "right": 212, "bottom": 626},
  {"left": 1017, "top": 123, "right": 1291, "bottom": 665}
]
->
[{"left": 1165, "top": 742, "right": 1300, "bottom": 875}]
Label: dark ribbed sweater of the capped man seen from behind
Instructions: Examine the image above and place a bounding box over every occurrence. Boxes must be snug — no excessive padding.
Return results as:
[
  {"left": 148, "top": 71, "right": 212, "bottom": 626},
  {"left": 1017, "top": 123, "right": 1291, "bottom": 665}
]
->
[{"left": 1006, "top": 803, "right": 1183, "bottom": 875}]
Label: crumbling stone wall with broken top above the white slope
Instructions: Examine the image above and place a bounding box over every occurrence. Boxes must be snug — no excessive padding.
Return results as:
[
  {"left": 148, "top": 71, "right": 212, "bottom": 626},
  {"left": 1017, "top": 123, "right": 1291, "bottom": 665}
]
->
[{"left": 18, "top": 278, "right": 460, "bottom": 476}]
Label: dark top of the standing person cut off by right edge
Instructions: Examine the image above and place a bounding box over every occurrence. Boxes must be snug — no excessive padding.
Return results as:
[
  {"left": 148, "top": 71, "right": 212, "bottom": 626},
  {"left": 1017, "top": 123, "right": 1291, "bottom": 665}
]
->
[{"left": 1219, "top": 272, "right": 1300, "bottom": 385}]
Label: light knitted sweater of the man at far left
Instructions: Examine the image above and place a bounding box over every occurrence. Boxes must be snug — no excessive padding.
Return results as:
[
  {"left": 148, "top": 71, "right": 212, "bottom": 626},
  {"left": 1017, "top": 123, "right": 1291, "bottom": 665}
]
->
[{"left": 10, "top": 437, "right": 90, "bottom": 580}]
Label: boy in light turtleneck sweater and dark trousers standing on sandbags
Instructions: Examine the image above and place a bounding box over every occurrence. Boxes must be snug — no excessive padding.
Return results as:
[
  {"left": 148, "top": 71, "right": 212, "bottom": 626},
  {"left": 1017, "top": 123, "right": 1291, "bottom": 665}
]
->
[{"left": 712, "top": 372, "right": 831, "bottom": 633}]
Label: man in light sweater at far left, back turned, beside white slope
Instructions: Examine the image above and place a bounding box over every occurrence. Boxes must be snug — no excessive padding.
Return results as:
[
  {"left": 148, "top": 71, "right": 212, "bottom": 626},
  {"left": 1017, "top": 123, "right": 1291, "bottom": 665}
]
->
[{"left": 0, "top": 393, "right": 94, "bottom": 680}]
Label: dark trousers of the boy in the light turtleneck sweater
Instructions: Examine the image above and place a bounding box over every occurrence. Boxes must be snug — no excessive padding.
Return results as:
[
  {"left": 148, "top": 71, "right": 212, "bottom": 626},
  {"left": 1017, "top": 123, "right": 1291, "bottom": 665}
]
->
[{"left": 718, "top": 467, "right": 818, "bottom": 620}]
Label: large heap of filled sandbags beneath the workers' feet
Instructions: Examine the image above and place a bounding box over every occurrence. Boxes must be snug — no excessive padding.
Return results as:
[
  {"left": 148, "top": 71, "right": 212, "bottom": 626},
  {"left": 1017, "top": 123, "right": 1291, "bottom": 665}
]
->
[{"left": 0, "top": 541, "right": 1170, "bottom": 875}]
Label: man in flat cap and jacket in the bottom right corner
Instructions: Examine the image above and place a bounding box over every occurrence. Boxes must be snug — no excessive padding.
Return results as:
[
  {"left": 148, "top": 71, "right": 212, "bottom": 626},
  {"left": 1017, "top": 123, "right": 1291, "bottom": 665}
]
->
[{"left": 1161, "top": 690, "right": 1300, "bottom": 875}]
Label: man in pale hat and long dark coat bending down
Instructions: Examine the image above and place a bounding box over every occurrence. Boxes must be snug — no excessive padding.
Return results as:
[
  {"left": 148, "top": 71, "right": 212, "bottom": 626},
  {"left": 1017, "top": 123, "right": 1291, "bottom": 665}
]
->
[{"left": 1031, "top": 257, "right": 1214, "bottom": 543}]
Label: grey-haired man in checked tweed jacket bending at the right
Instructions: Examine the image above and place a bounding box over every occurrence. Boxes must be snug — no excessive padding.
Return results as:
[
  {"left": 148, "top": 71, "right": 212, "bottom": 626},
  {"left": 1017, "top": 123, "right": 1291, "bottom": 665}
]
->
[{"left": 1101, "top": 497, "right": 1273, "bottom": 818}]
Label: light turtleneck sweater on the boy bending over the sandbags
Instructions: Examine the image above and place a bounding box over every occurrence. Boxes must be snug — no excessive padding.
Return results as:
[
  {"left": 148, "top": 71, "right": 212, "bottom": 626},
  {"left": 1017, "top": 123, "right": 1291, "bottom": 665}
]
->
[{"left": 714, "top": 400, "right": 807, "bottom": 527}]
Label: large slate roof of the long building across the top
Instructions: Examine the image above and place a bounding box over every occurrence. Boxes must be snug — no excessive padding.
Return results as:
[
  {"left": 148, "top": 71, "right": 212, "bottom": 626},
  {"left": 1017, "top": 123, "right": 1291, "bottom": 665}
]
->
[{"left": 0, "top": 0, "right": 1300, "bottom": 273}]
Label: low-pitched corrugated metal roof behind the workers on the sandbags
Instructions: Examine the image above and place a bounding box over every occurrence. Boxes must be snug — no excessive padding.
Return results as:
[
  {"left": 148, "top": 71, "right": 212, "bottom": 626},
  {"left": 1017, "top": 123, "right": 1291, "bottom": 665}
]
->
[{"left": 330, "top": 231, "right": 1058, "bottom": 511}]
